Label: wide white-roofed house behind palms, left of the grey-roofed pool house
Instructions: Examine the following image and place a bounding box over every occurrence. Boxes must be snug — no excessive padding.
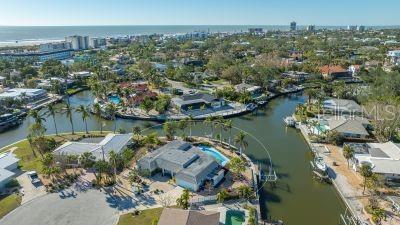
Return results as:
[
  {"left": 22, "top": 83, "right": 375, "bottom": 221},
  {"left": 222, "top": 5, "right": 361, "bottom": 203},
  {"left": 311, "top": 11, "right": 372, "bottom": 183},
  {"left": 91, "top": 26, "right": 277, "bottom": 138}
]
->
[{"left": 53, "top": 134, "right": 132, "bottom": 161}]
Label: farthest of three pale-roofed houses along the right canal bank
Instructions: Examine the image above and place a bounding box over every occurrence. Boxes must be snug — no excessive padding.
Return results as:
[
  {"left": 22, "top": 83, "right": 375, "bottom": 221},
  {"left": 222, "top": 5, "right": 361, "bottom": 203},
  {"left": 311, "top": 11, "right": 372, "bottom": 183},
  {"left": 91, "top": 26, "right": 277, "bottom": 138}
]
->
[{"left": 322, "top": 98, "right": 363, "bottom": 115}]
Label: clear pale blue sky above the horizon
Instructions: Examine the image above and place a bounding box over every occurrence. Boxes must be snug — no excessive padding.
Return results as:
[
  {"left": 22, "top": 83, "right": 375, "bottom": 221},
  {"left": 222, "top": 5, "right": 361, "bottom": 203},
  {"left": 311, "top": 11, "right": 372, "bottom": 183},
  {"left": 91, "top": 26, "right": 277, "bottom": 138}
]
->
[{"left": 0, "top": 0, "right": 400, "bottom": 26}]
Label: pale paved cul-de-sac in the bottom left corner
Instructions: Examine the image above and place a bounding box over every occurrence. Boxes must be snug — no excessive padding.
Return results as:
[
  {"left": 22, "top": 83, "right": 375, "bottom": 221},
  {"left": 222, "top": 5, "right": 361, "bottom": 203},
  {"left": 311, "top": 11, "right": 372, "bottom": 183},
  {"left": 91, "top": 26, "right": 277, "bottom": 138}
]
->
[{"left": 0, "top": 189, "right": 122, "bottom": 225}]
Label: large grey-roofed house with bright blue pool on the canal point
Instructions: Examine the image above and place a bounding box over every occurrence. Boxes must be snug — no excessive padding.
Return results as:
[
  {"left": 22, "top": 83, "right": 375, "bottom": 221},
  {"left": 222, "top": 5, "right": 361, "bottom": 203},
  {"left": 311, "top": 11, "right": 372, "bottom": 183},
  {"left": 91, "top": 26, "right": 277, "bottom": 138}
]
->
[{"left": 137, "top": 140, "right": 229, "bottom": 191}]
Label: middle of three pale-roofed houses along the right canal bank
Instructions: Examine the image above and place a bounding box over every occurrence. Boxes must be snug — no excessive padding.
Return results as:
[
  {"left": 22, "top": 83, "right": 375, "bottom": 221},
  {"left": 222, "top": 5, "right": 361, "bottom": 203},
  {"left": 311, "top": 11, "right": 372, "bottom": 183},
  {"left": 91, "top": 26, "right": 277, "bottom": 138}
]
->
[{"left": 315, "top": 116, "right": 370, "bottom": 140}]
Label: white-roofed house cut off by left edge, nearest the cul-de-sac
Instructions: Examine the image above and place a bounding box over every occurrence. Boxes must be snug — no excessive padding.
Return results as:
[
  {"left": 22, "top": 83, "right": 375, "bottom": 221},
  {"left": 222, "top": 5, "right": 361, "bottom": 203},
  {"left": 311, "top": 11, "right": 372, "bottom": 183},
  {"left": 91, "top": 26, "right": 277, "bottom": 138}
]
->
[{"left": 0, "top": 153, "right": 19, "bottom": 193}]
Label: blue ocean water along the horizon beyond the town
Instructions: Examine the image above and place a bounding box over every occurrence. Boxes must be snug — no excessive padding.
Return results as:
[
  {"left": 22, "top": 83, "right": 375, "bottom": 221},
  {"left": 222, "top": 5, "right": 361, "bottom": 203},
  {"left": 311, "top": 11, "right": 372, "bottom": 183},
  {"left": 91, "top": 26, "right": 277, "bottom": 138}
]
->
[{"left": 0, "top": 25, "right": 393, "bottom": 46}]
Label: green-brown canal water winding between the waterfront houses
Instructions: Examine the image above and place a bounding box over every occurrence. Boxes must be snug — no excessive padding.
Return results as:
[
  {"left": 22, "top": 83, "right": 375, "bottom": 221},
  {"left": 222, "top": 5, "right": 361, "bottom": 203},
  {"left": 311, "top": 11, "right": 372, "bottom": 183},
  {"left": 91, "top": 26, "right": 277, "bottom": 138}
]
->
[{"left": 0, "top": 91, "right": 344, "bottom": 225}]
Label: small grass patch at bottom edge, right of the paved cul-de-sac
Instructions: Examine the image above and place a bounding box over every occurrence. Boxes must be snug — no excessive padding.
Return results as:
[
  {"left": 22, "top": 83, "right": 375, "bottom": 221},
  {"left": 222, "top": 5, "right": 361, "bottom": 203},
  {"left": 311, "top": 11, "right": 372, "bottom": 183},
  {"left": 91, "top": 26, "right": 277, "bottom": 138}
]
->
[{"left": 118, "top": 208, "right": 163, "bottom": 225}]
